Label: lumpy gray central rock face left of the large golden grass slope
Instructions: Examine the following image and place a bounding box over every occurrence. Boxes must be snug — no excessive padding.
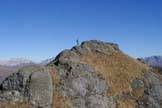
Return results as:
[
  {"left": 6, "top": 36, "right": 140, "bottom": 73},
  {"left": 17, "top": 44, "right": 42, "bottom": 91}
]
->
[{"left": 53, "top": 46, "right": 116, "bottom": 108}]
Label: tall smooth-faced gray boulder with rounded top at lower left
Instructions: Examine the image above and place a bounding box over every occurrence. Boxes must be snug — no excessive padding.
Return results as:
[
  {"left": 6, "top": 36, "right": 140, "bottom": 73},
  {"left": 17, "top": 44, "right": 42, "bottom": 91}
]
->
[{"left": 29, "top": 72, "right": 53, "bottom": 108}]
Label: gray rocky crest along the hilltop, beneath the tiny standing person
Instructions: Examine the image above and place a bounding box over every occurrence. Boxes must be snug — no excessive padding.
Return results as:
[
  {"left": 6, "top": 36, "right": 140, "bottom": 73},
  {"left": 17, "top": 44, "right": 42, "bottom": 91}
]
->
[{"left": 49, "top": 40, "right": 120, "bottom": 65}]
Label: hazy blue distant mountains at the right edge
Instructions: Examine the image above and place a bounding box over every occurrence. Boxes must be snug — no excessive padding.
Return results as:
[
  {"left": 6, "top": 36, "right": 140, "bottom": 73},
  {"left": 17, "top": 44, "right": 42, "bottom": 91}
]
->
[{"left": 142, "top": 56, "right": 162, "bottom": 68}]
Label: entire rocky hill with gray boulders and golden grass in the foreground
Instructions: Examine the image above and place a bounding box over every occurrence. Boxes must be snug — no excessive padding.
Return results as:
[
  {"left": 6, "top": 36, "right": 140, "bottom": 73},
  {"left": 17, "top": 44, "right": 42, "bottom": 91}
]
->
[{"left": 0, "top": 40, "right": 162, "bottom": 108}]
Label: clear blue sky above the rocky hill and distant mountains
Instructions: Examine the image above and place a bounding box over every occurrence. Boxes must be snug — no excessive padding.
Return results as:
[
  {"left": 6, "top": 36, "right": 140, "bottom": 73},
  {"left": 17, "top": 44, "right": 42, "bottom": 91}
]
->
[{"left": 0, "top": 0, "right": 162, "bottom": 61}]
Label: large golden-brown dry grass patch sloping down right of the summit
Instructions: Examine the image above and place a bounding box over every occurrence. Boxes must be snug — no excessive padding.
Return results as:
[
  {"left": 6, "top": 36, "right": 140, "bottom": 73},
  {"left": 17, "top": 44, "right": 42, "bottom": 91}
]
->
[{"left": 81, "top": 52, "right": 149, "bottom": 108}]
